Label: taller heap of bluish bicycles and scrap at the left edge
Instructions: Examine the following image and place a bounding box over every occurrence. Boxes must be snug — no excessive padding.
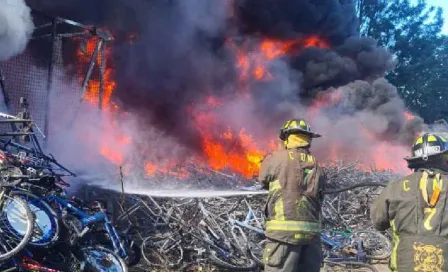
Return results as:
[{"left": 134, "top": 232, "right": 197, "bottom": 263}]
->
[{"left": 0, "top": 98, "right": 140, "bottom": 272}]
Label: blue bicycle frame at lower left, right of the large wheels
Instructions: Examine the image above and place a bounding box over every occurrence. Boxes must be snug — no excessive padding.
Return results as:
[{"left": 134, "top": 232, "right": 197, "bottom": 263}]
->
[{"left": 43, "top": 195, "right": 127, "bottom": 257}]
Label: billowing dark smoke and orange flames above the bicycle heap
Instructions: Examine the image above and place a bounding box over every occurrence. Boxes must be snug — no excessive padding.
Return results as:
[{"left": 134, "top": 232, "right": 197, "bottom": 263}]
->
[{"left": 0, "top": 0, "right": 424, "bottom": 187}]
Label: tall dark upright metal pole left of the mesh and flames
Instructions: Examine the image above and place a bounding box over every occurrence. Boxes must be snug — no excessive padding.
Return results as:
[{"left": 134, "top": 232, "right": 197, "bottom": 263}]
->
[{"left": 44, "top": 18, "right": 58, "bottom": 148}]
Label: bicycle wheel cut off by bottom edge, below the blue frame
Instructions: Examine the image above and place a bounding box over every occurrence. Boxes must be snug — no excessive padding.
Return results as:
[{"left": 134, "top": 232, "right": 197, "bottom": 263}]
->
[{"left": 78, "top": 246, "right": 128, "bottom": 272}]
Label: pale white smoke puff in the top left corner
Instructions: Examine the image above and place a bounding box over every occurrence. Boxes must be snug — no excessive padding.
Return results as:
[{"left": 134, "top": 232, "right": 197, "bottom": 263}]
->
[{"left": 0, "top": 0, "right": 34, "bottom": 61}]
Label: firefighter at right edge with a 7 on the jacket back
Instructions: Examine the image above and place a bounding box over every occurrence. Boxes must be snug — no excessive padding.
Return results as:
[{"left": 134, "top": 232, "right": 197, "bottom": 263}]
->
[{"left": 370, "top": 133, "right": 448, "bottom": 272}]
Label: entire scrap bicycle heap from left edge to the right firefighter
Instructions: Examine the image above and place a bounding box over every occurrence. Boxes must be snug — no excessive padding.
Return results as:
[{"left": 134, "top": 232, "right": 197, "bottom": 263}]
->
[{"left": 0, "top": 96, "right": 396, "bottom": 272}]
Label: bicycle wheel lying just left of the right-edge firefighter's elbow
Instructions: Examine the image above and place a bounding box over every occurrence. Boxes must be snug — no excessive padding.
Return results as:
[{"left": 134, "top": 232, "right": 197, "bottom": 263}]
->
[{"left": 354, "top": 231, "right": 392, "bottom": 260}]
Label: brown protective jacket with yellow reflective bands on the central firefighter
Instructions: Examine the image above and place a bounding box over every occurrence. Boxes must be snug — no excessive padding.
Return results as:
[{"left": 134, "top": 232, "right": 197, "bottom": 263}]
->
[{"left": 259, "top": 148, "right": 325, "bottom": 245}]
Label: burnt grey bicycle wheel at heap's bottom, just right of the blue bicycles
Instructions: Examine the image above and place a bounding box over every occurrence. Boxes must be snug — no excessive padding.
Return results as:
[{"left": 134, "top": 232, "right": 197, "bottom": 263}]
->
[{"left": 141, "top": 234, "right": 184, "bottom": 268}]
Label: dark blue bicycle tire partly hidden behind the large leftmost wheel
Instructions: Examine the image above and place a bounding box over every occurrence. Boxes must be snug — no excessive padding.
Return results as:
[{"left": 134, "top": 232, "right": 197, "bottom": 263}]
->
[{"left": 10, "top": 191, "right": 60, "bottom": 247}]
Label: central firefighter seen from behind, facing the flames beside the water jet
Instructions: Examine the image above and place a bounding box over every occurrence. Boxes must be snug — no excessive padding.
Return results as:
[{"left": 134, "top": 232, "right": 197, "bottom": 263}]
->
[{"left": 259, "top": 119, "right": 326, "bottom": 272}]
